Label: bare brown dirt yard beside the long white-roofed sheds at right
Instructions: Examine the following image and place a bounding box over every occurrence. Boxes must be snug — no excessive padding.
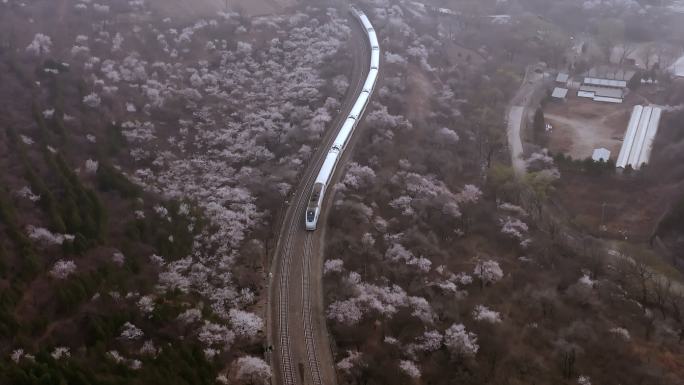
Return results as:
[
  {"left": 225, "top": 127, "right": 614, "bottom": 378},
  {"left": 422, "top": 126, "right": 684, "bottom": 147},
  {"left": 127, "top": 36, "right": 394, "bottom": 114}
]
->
[{"left": 544, "top": 95, "right": 641, "bottom": 159}]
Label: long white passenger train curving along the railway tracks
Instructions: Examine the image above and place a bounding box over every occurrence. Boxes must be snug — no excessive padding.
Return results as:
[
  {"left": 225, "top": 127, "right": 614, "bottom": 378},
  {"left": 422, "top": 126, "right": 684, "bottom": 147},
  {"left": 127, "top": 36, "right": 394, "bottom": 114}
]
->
[{"left": 304, "top": 7, "right": 380, "bottom": 230}]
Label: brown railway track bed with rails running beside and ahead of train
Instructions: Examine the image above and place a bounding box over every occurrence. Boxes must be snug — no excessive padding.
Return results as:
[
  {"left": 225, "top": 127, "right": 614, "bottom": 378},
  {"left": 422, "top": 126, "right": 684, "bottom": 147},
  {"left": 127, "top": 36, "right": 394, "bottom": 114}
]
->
[{"left": 267, "top": 15, "right": 370, "bottom": 385}]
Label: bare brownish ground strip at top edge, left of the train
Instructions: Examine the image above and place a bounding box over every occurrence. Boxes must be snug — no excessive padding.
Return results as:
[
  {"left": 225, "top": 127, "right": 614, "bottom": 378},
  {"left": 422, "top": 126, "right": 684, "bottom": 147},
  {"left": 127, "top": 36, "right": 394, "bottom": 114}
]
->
[{"left": 149, "top": 0, "right": 294, "bottom": 19}]
